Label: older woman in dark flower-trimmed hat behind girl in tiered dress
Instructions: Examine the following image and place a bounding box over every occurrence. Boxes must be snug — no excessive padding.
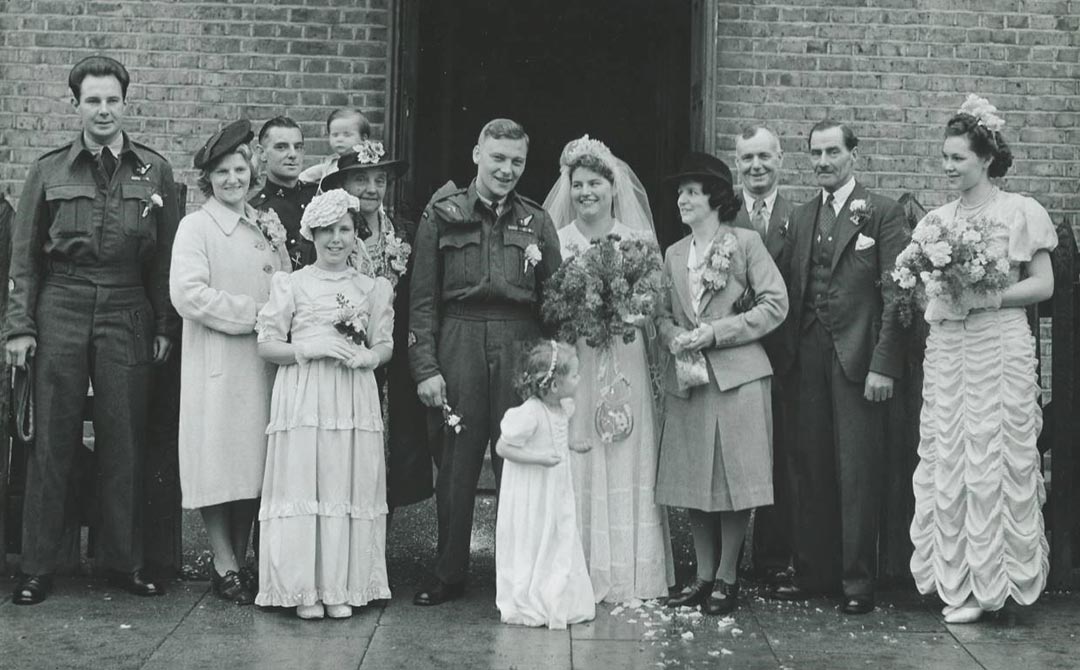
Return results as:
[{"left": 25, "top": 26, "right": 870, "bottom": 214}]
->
[{"left": 320, "top": 139, "right": 434, "bottom": 510}]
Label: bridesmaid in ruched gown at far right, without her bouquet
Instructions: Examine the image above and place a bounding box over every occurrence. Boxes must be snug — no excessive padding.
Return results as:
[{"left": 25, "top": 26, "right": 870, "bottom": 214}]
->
[{"left": 910, "top": 96, "right": 1057, "bottom": 624}]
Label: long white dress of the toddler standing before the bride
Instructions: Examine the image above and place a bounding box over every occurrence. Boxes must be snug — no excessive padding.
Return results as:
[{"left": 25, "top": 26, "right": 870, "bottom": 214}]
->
[{"left": 495, "top": 398, "right": 596, "bottom": 630}]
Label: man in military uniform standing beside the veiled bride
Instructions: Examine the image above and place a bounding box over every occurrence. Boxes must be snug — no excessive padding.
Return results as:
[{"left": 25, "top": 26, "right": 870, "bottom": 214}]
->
[{"left": 408, "top": 119, "right": 562, "bottom": 605}]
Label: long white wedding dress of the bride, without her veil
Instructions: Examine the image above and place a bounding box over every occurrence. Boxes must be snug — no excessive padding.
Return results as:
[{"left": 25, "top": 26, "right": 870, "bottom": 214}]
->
[{"left": 558, "top": 222, "right": 675, "bottom": 602}]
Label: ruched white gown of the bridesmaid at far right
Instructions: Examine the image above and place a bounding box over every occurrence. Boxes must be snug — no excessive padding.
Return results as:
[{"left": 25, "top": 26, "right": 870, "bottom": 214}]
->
[{"left": 910, "top": 192, "right": 1057, "bottom": 611}]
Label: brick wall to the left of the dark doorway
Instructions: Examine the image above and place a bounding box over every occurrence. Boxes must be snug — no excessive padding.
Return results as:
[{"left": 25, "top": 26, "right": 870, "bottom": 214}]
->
[{"left": 0, "top": 0, "right": 389, "bottom": 200}]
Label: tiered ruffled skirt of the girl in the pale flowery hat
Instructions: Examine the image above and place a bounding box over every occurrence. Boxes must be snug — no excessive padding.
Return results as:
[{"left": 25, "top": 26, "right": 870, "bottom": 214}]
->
[{"left": 255, "top": 361, "right": 390, "bottom": 607}]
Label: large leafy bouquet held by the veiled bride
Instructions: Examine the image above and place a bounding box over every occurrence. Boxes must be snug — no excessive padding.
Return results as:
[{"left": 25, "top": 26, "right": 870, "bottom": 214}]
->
[{"left": 543, "top": 235, "right": 663, "bottom": 350}]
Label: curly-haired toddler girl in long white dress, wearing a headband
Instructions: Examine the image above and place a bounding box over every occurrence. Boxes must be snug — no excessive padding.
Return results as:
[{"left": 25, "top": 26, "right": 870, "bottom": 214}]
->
[{"left": 495, "top": 341, "right": 596, "bottom": 630}]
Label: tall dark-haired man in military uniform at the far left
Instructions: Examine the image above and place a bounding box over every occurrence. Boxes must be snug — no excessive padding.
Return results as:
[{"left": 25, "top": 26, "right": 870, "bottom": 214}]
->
[{"left": 5, "top": 56, "right": 179, "bottom": 605}]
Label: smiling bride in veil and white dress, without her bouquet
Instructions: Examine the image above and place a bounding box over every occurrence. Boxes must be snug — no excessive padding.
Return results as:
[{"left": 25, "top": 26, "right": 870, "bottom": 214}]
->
[{"left": 544, "top": 135, "right": 675, "bottom": 602}]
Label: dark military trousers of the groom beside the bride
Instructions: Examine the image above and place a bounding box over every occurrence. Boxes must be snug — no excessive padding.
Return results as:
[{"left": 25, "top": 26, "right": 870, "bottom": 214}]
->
[{"left": 432, "top": 308, "right": 540, "bottom": 584}]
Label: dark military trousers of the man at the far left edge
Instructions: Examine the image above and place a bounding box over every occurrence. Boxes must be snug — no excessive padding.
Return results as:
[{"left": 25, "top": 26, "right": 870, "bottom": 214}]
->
[{"left": 22, "top": 277, "right": 154, "bottom": 574}]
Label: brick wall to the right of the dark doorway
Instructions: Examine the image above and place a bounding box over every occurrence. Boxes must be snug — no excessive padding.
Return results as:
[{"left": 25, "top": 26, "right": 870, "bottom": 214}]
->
[{"left": 716, "top": 0, "right": 1080, "bottom": 231}]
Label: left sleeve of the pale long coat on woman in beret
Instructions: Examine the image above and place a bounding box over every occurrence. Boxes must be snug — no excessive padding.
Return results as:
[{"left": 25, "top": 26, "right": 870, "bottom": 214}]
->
[{"left": 168, "top": 212, "right": 258, "bottom": 335}]
